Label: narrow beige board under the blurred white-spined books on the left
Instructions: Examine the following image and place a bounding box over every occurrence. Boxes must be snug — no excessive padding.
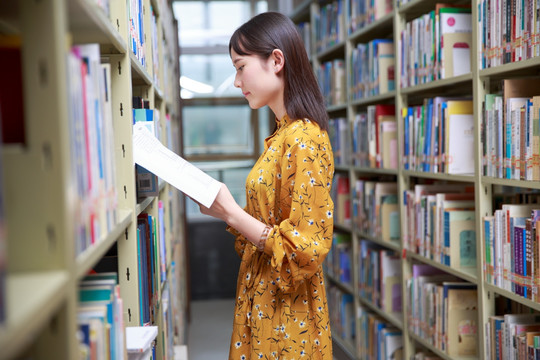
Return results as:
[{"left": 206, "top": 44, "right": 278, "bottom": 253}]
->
[{"left": 75, "top": 210, "right": 132, "bottom": 280}]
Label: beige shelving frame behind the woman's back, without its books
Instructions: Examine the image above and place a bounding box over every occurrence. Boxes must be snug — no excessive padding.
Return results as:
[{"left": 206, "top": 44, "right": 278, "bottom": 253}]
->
[{"left": 292, "top": 0, "right": 540, "bottom": 359}]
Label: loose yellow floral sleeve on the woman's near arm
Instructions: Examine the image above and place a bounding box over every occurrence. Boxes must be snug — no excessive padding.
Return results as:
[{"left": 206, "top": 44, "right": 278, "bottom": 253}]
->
[{"left": 264, "top": 126, "right": 334, "bottom": 293}]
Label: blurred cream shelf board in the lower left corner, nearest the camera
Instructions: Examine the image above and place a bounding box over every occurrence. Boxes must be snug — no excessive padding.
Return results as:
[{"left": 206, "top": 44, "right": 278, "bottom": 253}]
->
[{"left": 0, "top": 271, "right": 70, "bottom": 359}]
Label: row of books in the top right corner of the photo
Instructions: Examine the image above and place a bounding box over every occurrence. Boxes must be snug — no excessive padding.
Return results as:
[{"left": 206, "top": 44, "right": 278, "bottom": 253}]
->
[{"left": 477, "top": 0, "right": 540, "bottom": 69}]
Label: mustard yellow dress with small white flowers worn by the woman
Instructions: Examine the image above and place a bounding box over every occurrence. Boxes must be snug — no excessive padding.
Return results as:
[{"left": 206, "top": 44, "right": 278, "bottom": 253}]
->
[{"left": 228, "top": 116, "right": 334, "bottom": 360}]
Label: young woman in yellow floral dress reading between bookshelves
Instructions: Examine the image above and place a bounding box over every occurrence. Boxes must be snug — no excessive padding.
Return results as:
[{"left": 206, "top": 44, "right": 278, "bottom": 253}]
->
[{"left": 201, "top": 12, "right": 334, "bottom": 360}]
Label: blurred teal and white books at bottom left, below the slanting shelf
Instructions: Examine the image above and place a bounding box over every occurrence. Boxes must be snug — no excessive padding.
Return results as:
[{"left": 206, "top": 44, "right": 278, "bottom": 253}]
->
[{"left": 77, "top": 272, "right": 126, "bottom": 360}]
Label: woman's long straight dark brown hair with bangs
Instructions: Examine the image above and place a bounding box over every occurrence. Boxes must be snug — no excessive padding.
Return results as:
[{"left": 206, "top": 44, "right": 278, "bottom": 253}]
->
[{"left": 229, "top": 12, "right": 328, "bottom": 130}]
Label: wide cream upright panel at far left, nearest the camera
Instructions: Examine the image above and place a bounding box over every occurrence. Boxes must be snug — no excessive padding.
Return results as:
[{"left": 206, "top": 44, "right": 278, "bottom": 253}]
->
[{"left": 11, "top": 0, "right": 76, "bottom": 359}]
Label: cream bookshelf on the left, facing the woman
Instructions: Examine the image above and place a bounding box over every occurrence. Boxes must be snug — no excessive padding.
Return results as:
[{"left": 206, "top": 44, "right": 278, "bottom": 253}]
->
[{"left": 0, "top": 0, "right": 187, "bottom": 360}]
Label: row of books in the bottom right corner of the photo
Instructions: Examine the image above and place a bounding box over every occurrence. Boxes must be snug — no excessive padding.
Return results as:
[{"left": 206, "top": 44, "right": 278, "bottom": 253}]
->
[{"left": 485, "top": 313, "right": 540, "bottom": 360}]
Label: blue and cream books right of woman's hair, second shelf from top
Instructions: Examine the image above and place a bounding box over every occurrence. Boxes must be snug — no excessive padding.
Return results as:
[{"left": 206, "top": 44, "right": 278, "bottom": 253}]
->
[{"left": 349, "top": 39, "right": 395, "bottom": 100}]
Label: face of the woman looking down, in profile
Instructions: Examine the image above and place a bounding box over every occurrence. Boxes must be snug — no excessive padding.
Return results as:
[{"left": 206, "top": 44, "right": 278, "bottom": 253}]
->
[{"left": 231, "top": 49, "right": 284, "bottom": 115}]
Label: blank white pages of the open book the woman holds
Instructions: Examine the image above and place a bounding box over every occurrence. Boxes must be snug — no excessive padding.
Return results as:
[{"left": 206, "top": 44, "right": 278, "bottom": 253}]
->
[{"left": 133, "top": 123, "right": 221, "bottom": 208}]
